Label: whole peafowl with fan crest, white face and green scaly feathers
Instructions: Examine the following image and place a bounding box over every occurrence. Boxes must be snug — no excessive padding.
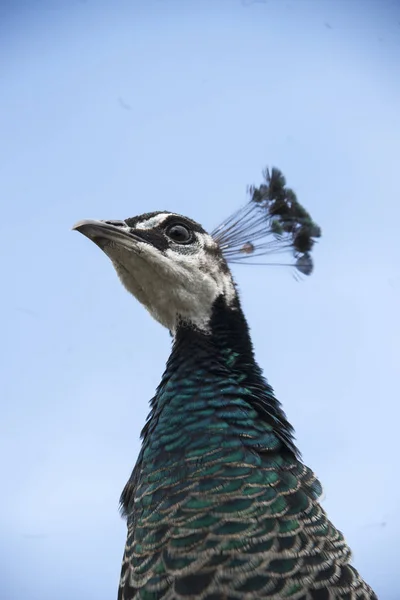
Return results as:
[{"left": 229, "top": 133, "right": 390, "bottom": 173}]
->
[{"left": 74, "top": 168, "right": 377, "bottom": 600}]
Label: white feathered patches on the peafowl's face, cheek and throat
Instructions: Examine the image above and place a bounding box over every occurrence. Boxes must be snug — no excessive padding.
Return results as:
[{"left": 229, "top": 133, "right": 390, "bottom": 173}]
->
[{"left": 105, "top": 227, "right": 236, "bottom": 333}]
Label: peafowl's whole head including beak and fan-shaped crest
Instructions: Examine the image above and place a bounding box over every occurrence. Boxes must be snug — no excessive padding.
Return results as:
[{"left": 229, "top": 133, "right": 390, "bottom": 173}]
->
[{"left": 73, "top": 168, "right": 321, "bottom": 333}]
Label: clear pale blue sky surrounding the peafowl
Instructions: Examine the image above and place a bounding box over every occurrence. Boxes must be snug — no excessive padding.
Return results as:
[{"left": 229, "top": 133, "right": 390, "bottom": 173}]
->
[{"left": 0, "top": 0, "right": 400, "bottom": 600}]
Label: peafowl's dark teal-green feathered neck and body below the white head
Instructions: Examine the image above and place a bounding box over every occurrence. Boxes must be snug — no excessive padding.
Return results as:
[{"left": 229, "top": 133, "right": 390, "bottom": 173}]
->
[{"left": 119, "top": 301, "right": 377, "bottom": 600}]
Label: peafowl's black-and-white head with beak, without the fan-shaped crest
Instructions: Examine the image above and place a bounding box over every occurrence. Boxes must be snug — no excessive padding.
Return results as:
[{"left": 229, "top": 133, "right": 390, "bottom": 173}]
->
[{"left": 73, "top": 211, "right": 236, "bottom": 333}]
